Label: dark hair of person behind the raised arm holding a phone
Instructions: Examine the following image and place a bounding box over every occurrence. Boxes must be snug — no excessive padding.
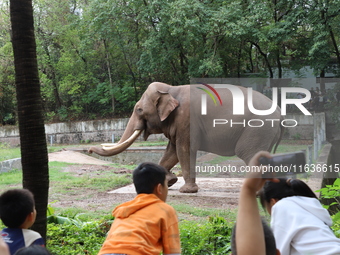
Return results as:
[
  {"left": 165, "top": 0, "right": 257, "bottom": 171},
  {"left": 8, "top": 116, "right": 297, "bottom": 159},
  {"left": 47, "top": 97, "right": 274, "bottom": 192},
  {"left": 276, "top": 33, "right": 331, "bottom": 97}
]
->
[{"left": 231, "top": 219, "right": 276, "bottom": 255}]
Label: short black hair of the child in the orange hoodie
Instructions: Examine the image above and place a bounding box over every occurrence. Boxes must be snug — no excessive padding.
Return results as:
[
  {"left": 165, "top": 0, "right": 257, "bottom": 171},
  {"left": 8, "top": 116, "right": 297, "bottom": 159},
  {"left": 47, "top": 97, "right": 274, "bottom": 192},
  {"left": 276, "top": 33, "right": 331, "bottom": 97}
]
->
[{"left": 132, "top": 162, "right": 167, "bottom": 194}]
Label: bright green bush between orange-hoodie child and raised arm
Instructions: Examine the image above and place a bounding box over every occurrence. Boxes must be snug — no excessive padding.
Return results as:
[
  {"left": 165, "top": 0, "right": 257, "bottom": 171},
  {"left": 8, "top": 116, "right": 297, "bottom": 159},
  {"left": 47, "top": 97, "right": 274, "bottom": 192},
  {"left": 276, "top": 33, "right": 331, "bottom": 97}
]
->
[{"left": 180, "top": 217, "right": 232, "bottom": 255}]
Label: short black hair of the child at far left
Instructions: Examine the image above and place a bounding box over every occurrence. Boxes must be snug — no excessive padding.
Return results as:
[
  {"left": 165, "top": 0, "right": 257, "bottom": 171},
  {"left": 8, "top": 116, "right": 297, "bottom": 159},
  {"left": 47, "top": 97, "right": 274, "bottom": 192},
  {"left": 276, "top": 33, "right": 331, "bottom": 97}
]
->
[{"left": 0, "top": 189, "right": 35, "bottom": 228}]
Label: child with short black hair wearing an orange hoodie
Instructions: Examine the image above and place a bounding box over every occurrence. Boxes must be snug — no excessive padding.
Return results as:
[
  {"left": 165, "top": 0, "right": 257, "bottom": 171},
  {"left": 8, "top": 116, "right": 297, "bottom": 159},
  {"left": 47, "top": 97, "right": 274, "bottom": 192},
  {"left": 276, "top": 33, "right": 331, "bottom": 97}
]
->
[{"left": 98, "top": 163, "right": 181, "bottom": 255}]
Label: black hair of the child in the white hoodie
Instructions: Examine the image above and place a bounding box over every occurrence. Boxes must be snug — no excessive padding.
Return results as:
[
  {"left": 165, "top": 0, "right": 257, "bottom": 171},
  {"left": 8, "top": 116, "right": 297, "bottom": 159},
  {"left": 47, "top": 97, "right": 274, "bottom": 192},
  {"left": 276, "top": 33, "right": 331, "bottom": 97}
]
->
[{"left": 259, "top": 178, "right": 317, "bottom": 208}]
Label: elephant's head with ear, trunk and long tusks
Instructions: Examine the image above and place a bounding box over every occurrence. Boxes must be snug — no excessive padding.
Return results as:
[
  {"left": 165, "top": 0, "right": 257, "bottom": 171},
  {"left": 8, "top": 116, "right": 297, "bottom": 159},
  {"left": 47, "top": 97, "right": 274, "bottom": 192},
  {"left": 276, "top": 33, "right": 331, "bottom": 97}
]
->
[{"left": 89, "top": 82, "right": 179, "bottom": 156}]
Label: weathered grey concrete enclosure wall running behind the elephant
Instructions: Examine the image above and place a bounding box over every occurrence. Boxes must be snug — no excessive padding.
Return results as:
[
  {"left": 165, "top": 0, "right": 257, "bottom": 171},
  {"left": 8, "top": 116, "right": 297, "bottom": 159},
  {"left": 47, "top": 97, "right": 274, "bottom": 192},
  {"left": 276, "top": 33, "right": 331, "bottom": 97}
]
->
[{"left": 0, "top": 114, "right": 322, "bottom": 146}]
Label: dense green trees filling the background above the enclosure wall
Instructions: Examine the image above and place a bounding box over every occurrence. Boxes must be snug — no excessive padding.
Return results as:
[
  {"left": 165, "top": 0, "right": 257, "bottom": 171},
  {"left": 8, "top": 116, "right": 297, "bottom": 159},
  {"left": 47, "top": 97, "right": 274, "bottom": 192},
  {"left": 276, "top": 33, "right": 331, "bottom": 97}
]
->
[{"left": 0, "top": 0, "right": 340, "bottom": 121}]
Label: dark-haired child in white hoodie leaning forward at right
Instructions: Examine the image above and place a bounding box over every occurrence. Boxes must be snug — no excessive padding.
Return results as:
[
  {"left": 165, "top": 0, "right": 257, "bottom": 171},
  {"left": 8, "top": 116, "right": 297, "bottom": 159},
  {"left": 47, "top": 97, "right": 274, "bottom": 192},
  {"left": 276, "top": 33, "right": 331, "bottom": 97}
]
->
[{"left": 259, "top": 178, "right": 340, "bottom": 255}]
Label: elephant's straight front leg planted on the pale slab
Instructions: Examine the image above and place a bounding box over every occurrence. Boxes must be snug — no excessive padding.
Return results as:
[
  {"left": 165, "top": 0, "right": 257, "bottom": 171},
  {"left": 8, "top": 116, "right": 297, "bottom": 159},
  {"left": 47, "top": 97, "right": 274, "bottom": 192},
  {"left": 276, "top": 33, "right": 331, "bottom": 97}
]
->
[{"left": 177, "top": 145, "right": 198, "bottom": 193}]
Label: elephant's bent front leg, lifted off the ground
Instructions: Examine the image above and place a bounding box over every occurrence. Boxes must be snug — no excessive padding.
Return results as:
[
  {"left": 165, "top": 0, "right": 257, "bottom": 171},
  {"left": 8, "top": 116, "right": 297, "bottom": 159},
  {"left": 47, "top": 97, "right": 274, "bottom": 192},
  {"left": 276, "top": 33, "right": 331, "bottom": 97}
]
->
[{"left": 159, "top": 141, "right": 178, "bottom": 187}]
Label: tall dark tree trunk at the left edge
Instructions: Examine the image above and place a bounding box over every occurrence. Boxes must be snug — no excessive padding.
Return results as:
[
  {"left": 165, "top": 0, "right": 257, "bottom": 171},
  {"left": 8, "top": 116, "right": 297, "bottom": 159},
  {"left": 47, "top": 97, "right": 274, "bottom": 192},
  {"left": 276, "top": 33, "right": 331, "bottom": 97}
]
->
[{"left": 10, "top": 0, "right": 49, "bottom": 238}]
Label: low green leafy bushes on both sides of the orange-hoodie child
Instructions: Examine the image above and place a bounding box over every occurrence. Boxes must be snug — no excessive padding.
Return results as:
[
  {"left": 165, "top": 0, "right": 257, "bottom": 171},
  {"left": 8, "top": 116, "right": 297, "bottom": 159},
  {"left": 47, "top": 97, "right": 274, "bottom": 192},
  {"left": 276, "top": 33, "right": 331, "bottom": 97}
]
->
[{"left": 47, "top": 215, "right": 232, "bottom": 255}]
